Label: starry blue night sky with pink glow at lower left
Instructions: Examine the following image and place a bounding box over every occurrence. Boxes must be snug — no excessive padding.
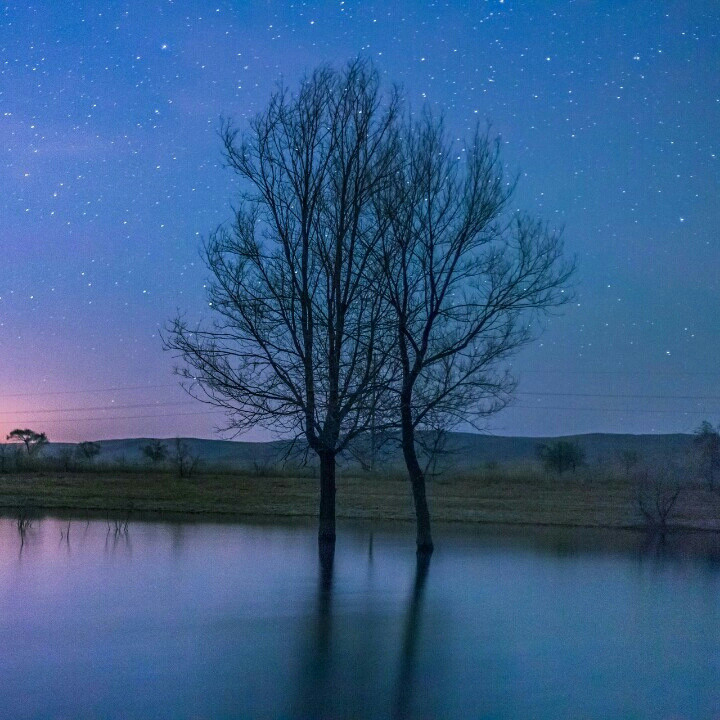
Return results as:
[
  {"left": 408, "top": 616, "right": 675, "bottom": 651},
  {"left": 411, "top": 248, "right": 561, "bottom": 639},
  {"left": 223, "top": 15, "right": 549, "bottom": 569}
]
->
[{"left": 0, "top": 0, "right": 720, "bottom": 441}]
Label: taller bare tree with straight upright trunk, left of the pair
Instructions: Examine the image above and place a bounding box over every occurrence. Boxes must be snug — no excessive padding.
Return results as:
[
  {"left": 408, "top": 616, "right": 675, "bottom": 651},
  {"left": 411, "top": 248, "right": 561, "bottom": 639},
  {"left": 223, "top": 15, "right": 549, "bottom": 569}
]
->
[{"left": 165, "top": 60, "right": 398, "bottom": 542}]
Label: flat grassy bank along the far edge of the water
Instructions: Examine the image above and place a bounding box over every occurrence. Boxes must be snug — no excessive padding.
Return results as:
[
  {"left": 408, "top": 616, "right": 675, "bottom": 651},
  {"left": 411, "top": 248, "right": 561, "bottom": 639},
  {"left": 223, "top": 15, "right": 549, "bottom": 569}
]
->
[{"left": 0, "top": 471, "right": 720, "bottom": 530}]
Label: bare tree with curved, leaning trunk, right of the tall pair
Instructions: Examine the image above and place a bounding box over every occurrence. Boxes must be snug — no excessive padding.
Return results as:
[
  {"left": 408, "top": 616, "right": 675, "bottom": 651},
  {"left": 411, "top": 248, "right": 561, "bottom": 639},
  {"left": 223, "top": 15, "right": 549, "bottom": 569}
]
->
[{"left": 377, "top": 113, "right": 573, "bottom": 551}]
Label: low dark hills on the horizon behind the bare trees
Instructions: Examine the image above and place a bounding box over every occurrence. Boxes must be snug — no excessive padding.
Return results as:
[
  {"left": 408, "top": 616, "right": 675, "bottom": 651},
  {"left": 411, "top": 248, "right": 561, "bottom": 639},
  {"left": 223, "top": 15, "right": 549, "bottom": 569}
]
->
[{"left": 33, "top": 433, "right": 693, "bottom": 470}]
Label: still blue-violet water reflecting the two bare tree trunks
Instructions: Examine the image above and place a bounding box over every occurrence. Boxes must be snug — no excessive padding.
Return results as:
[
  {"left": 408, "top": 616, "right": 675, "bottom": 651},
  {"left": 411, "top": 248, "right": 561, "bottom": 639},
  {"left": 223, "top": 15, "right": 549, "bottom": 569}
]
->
[{"left": 0, "top": 519, "right": 720, "bottom": 720}]
